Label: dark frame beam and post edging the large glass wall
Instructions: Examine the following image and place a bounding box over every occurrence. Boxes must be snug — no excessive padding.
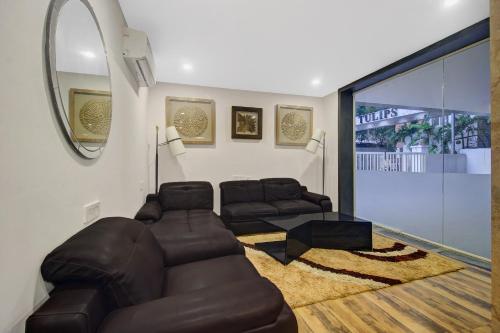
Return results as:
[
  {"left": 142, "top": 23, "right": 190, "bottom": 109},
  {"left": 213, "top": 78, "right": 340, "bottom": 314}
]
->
[{"left": 338, "top": 18, "right": 490, "bottom": 214}]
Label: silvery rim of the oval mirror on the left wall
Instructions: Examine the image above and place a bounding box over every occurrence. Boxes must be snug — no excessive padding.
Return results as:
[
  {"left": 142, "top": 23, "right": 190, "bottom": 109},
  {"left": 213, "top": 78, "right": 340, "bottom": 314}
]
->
[{"left": 44, "top": 0, "right": 113, "bottom": 159}]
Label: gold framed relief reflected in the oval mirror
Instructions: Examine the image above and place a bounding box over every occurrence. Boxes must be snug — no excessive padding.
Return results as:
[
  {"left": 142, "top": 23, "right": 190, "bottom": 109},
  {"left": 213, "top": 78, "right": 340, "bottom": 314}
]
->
[{"left": 69, "top": 88, "right": 111, "bottom": 143}]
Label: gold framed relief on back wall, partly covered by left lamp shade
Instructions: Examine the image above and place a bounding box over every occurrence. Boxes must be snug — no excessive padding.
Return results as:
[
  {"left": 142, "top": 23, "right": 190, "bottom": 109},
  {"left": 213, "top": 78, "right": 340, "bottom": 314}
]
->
[{"left": 165, "top": 97, "right": 215, "bottom": 144}]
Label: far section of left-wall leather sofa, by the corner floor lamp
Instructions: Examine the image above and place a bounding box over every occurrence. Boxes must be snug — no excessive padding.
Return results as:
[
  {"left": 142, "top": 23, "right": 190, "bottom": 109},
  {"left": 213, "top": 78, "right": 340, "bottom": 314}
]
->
[{"left": 135, "top": 182, "right": 244, "bottom": 265}]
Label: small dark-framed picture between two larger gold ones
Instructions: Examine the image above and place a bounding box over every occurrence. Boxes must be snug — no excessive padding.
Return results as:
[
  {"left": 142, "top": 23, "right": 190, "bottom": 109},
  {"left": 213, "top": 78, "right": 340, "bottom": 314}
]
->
[{"left": 231, "top": 106, "right": 262, "bottom": 140}]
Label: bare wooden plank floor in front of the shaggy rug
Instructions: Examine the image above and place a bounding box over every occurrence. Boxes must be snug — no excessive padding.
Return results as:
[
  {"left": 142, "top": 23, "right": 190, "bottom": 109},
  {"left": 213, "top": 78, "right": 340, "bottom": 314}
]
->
[{"left": 295, "top": 267, "right": 491, "bottom": 333}]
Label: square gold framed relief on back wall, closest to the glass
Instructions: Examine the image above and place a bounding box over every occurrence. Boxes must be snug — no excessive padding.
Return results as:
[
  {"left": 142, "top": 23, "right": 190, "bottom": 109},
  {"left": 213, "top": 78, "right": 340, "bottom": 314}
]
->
[{"left": 275, "top": 105, "right": 313, "bottom": 146}]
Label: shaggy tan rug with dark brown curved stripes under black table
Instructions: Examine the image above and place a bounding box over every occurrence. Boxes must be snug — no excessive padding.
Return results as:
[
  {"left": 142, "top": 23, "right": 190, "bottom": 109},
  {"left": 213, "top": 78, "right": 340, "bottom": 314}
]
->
[{"left": 238, "top": 233, "right": 464, "bottom": 308}]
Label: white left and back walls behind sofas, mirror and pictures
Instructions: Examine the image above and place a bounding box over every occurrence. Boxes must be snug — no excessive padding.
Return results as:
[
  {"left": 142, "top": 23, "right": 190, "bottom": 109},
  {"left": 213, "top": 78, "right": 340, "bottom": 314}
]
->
[{"left": 0, "top": 0, "right": 337, "bottom": 333}]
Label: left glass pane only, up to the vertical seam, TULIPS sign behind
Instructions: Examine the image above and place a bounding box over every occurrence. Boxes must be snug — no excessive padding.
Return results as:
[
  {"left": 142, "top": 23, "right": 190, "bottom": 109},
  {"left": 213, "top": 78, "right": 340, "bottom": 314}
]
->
[{"left": 355, "top": 61, "right": 443, "bottom": 242}]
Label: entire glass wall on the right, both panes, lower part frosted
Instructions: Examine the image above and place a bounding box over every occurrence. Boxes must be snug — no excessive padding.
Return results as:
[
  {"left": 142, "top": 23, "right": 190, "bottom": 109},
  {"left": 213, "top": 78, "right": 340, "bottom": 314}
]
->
[{"left": 354, "top": 41, "right": 491, "bottom": 258}]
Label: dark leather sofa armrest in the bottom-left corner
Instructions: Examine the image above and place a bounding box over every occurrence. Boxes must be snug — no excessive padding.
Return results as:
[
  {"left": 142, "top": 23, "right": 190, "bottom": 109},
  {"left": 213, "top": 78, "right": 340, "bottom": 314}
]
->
[{"left": 26, "top": 286, "right": 113, "bottom": 333}]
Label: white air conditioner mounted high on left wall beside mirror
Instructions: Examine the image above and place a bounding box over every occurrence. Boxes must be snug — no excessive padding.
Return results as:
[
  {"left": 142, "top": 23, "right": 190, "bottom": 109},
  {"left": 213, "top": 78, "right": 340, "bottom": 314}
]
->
[{"left": 123, "top": 28, "right": 156, "bottom": 87}]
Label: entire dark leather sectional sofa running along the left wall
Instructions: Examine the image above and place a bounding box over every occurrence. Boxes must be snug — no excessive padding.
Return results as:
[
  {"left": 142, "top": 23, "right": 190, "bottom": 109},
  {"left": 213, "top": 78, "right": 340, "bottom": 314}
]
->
[{"left": 26, "top": 182, "right": 297, "bottom": 333}]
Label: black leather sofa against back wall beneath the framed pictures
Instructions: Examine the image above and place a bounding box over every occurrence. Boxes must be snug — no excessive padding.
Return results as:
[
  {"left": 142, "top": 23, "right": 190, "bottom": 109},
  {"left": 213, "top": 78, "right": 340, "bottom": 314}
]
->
[{"left": 219, "top": 178, "right": 332, "bottom": 235}]
